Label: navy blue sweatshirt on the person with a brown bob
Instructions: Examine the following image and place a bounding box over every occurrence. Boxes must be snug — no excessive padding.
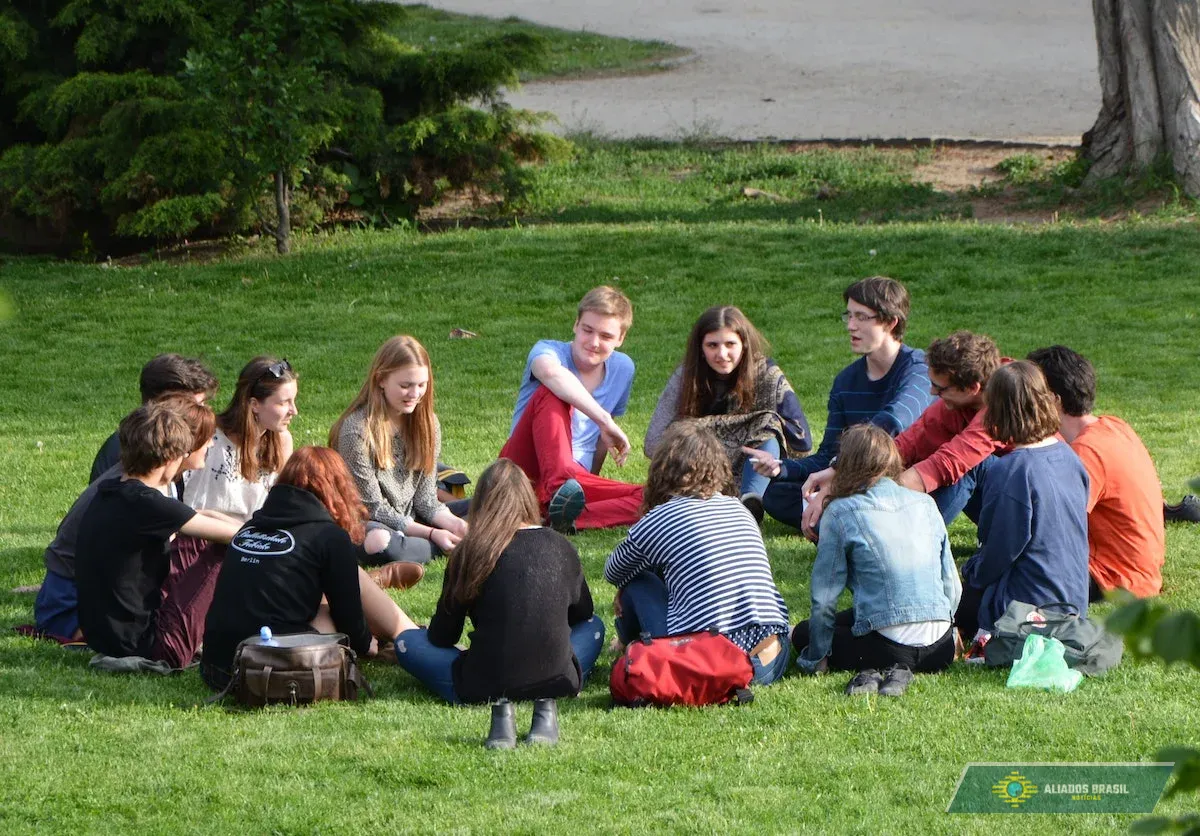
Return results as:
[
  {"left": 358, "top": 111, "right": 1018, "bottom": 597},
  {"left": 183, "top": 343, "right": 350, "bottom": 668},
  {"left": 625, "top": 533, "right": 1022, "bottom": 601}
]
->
[{"left": 962, "top": 441, "right": 1088, "bottom": 632}]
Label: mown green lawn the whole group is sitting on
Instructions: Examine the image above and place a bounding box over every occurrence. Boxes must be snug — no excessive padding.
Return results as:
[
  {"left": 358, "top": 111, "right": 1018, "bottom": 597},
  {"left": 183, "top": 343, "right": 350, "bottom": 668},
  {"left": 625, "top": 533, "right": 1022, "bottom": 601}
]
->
[{"left": 0, "top": 210, "right": 1200, "bottom": 834}]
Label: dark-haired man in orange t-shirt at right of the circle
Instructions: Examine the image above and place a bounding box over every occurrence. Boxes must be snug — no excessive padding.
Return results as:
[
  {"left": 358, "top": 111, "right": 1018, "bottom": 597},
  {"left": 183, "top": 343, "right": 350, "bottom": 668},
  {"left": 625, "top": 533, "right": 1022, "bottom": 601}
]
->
[{"left": 1028, "top": 345, "right": 1166, "bottom": 601}]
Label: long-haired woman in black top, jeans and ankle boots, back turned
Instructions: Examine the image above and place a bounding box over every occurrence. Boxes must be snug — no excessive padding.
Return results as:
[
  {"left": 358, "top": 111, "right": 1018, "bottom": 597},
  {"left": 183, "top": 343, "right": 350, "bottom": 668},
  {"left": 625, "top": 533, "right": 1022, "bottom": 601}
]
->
[{"left": 396, "top": 458, "right": 604, "bottom": 747}]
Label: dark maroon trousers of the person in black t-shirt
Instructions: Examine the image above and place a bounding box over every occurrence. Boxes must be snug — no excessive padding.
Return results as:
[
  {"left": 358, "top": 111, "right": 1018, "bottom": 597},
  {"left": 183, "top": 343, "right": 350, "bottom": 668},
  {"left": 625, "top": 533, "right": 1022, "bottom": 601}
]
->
[{"left": 152, "top": 534, "right": 226, "bottom": 668}]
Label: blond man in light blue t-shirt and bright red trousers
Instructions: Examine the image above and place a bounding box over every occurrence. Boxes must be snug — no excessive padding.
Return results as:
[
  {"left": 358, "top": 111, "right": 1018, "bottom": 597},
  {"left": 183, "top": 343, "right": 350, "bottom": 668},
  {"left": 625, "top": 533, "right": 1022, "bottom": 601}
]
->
[{"left": 500, "top": 287, "right": 642, "bottom": 531}]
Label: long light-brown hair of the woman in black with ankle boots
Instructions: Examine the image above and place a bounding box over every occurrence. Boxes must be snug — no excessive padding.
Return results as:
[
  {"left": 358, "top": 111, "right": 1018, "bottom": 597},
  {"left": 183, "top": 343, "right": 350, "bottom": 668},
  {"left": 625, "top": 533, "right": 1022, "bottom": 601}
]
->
[{"left": 445, "top": 458, "right": 541, "bottom": 606}]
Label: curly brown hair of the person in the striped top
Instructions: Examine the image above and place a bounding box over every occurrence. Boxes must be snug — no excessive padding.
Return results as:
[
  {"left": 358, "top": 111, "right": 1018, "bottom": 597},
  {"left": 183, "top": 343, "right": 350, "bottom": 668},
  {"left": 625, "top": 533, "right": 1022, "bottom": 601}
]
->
[{"left": 642, "top": 421, "right": 734, "bottom": 513}]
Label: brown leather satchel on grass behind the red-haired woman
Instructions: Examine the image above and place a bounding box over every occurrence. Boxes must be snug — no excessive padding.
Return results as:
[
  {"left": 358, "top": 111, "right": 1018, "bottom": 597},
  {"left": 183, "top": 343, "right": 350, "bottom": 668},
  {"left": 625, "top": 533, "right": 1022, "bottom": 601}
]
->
[{"left": 212, "top": 633, "right": 374, "bottom": 708}]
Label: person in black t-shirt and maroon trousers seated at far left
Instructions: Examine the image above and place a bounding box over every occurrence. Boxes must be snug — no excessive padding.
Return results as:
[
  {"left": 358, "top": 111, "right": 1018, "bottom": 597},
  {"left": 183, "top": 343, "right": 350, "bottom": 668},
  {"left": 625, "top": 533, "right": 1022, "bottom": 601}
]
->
[{"left": 76, "top": 402, "right": 238, "bottom": 668}]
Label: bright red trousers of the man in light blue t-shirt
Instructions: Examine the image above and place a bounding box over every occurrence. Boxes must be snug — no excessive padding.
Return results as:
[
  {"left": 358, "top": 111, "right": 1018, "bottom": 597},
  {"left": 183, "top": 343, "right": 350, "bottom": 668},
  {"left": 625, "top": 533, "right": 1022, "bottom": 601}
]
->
[{"left": 500, "top": 386, "right": 642, "bottom": 529}]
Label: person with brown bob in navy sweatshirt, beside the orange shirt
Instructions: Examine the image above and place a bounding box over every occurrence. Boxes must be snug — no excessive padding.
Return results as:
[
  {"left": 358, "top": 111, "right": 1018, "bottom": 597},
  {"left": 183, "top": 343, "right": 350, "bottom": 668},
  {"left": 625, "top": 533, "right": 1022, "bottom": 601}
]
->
[{"left": 954, "top": 360, "right": 1090, "bottom": 658}]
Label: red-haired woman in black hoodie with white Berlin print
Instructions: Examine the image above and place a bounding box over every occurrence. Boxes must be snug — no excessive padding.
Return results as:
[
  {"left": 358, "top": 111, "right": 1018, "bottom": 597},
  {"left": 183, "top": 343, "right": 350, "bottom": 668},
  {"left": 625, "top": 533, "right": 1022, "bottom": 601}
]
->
[{"left": 200, "top": 447, "right": 421, "bottom": 688}]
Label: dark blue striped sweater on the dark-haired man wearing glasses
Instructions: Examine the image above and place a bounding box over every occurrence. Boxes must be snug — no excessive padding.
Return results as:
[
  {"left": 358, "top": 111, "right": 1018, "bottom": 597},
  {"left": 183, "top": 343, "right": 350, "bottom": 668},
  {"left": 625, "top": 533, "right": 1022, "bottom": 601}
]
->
[{"left": 775, "top": 345, "right": 934, "bottom": 482}]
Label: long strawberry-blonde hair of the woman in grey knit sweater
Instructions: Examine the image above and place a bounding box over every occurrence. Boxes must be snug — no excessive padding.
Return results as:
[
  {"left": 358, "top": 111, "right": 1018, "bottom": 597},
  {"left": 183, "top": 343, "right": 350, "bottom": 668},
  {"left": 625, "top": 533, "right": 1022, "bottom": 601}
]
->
[{"left": 329, "top": 335, "right": 437, "bottom": 473}]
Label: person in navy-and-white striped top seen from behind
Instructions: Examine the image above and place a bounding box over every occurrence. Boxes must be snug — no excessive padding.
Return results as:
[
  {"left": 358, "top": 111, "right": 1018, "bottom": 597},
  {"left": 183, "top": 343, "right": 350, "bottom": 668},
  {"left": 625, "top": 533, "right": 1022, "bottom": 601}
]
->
[{"left": 604, "top": 422, "right": 788, "bottom": 685}]
